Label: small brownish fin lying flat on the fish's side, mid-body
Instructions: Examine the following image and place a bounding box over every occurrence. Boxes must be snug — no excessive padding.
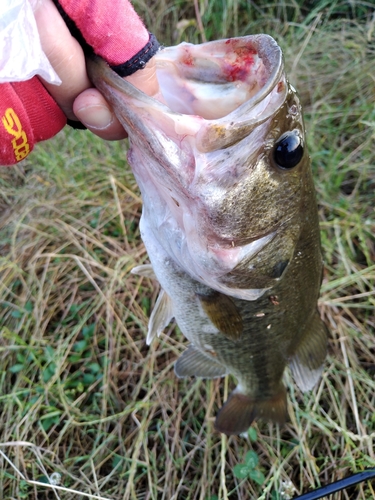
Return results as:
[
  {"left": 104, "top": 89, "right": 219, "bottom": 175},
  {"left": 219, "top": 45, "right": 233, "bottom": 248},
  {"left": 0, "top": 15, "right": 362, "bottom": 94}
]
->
[{"left": 197, "top": 292, "right": 243, "bottom": 340}]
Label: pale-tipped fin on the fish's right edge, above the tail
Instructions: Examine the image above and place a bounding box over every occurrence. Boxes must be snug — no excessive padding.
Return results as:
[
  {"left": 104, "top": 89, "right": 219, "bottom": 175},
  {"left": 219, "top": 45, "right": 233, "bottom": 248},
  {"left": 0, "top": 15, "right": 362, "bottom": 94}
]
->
[{"left": 289, "top": 311, "right": 328, "bottom": 391}]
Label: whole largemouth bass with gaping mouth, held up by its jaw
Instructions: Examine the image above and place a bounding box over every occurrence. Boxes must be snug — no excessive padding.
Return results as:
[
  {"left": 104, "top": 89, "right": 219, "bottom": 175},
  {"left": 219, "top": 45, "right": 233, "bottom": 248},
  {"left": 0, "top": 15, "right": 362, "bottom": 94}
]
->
[{"left": 87, "top": 34, "right": 328, "bottom": 435}]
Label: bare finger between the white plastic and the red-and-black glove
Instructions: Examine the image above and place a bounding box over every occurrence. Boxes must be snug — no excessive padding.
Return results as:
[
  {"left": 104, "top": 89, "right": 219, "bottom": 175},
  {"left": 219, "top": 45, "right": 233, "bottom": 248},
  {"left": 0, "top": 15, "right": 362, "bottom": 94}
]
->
[{"left": 34, "top": 0, "right": 91, "bottom": 120}]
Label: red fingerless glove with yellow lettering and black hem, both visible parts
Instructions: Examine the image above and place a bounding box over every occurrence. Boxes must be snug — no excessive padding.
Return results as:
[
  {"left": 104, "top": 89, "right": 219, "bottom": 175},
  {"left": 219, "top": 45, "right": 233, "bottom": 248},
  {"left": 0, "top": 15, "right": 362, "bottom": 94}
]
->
[{"left": 0, "top": 0, "right": 159, "bottom": 165}]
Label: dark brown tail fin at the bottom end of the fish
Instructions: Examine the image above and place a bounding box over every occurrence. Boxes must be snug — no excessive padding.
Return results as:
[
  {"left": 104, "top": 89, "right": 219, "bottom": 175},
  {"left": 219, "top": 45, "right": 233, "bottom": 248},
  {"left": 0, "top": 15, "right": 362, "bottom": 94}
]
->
[{"left": 215, "top": 384, "right": 288, "bottom": 435}]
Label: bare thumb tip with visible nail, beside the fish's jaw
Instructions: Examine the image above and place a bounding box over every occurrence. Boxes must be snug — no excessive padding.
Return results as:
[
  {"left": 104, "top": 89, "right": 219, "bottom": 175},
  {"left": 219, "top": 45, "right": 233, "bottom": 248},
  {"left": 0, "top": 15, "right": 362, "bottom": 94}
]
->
[{"left": 73, "top": 88, "right": 127, "bottom": 141}]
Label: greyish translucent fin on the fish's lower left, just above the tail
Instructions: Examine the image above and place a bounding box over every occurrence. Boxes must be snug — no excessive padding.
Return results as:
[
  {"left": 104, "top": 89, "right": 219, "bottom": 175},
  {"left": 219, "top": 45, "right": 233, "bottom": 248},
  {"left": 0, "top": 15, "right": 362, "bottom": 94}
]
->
[{"left": 174, "top": 345, "right": 227, "bottom": 378}]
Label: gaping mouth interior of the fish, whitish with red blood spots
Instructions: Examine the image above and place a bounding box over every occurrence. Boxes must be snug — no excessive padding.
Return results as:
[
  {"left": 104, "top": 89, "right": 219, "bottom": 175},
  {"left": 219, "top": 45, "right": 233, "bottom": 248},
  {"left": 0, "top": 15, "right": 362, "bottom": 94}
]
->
[{"left": 155, "top": 35, "right": 282, "bottom": 120}]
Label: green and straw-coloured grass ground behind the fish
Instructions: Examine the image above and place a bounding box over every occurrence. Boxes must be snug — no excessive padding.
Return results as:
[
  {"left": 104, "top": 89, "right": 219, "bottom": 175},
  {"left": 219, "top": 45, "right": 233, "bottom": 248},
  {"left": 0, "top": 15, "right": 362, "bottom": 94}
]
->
[{"left": 0, "top": 0, "right": 375, "bottom": 500}]
